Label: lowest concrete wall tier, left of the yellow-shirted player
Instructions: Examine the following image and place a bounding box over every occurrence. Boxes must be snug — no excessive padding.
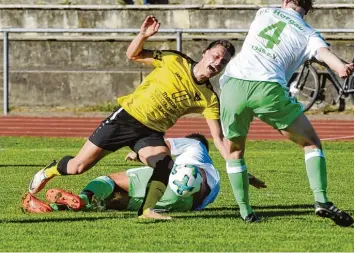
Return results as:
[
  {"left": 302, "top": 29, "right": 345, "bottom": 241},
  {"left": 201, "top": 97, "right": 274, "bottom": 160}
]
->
[{"left": 0, "top": 71, "right": 142, "bottom": 108}]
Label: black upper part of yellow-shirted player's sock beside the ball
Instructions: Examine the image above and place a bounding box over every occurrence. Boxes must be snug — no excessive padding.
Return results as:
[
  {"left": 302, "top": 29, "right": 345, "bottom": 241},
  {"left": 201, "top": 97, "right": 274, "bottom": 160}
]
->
[{"left": 147, "top": 154, "right": 174, "bottom": 184}]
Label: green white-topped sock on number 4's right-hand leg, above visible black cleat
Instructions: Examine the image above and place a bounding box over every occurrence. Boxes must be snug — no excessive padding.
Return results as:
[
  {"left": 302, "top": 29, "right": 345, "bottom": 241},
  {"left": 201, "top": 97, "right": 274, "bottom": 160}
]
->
[{"left": 305, "top": 149, "right": 328, "bottom": 203}]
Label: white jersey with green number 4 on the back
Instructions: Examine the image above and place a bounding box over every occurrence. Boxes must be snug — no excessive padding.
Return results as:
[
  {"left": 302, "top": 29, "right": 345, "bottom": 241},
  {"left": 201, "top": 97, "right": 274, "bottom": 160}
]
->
[{"left": 220, "top": 8, "right": 327, "bottom": 88}]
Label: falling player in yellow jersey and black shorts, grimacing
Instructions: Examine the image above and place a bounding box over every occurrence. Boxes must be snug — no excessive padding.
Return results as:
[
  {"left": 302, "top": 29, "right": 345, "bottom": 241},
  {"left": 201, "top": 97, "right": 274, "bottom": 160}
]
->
[{"left": 29, "top": 16, "right": 235, "bottom": 219}]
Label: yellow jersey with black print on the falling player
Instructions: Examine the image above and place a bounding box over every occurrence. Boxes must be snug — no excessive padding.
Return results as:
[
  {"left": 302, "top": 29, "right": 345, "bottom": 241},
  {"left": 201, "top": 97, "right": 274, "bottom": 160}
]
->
[{"left": 117, "top": 50, "right": 219, "bottom": 132}]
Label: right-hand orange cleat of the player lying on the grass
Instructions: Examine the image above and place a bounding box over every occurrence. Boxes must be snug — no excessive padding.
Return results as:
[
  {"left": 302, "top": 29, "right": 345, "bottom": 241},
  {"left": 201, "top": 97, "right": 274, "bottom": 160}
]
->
[{"left": 46, "top": 189, "right": 85, "bottom": 211}]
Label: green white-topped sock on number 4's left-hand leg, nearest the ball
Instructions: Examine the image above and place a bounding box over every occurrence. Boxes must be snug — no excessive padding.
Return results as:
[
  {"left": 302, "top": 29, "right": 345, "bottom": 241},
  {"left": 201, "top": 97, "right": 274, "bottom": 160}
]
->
[{"left": 227, "top": 159, "right": 253, "bottom": 219}]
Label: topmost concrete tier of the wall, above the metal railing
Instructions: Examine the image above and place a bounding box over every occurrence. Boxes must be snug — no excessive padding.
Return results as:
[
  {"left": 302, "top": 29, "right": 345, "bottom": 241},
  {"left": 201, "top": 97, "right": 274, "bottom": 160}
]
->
[{"left": 0, "top": 4, "right": 354, "bottom": 29}]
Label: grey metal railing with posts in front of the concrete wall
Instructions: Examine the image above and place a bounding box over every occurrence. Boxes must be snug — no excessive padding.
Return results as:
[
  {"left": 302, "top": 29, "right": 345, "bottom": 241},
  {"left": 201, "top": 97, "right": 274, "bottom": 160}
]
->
[{"left": 0, "top": 28, "right": 354, "bottom": 116}]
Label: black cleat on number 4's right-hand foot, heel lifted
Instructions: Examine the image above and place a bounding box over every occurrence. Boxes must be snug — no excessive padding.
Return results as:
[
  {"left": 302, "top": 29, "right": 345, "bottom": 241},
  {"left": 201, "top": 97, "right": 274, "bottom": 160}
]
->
[{"left": 314, "top": 202, "right": 354, "bottom": 227}]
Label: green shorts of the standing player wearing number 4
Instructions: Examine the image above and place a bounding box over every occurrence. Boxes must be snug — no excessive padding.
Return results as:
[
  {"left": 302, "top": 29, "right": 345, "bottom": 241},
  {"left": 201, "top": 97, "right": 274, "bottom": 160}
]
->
[{"left": 220, "top": 78, "right": 303, "bottom": 139}]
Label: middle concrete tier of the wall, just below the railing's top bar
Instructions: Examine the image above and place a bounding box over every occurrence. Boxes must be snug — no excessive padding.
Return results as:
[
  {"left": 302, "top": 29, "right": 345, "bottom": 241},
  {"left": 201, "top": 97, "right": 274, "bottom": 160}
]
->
[{"left": 0, "top": 38, "right": 353, "bottom": 71}]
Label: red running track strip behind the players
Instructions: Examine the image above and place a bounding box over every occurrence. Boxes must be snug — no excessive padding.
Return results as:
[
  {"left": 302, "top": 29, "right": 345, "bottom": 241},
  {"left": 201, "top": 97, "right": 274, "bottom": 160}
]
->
[{"left": 0, "top": 116, "right": 354, "bottom": 141}]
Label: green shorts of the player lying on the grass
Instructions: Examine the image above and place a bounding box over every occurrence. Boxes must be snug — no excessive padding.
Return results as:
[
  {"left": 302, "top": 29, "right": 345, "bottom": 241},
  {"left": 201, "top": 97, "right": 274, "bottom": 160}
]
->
[{"left": 126, "top": 166, "right": 193, "bottom": 211}]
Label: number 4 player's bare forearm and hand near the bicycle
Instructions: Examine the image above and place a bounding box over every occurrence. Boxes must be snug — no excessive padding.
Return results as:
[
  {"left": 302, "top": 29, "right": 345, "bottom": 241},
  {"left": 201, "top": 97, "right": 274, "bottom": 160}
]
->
[{"left": 317, "top": 47, "right": 354, "bottom": 78}]
